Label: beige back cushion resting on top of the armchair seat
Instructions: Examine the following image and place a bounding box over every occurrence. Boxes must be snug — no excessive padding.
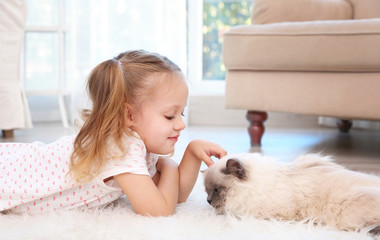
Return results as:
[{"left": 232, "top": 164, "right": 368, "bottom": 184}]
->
[{"left": 252, "top": 0, "right": 354, "bottom": 24}]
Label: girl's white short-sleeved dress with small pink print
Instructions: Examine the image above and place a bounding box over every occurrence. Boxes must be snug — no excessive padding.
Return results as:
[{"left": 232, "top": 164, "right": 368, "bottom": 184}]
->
[{"left": 0, "top": 133, "right": 158, "bottom": 214}]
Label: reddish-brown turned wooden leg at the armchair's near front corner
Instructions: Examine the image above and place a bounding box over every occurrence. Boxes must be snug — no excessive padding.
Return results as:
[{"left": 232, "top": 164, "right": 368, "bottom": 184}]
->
[{"left": 247, "top": 111, "right": 268, "bottom": 146}]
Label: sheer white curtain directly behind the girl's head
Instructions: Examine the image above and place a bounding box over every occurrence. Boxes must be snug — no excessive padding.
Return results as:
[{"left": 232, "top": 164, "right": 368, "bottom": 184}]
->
[{"left": 65, "top": 0, "right": 187, "bottom": 124}]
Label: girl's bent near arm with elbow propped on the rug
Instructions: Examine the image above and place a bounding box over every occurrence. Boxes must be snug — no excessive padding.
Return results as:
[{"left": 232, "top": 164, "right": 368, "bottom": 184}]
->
[{"left": 114, "top": 158, "right": 179, "bottom": 216}]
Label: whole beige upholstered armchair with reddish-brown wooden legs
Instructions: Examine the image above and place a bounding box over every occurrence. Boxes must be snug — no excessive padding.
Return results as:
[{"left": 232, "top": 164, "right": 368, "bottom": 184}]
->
[{"left": 223, "top": 0, "right": 380, "bottom": 145}]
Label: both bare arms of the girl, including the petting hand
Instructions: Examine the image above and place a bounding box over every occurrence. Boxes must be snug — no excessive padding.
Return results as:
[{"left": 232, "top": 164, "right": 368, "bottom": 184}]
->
[{"left": 114, "top": 140, "right": 227, "bottom": 216}]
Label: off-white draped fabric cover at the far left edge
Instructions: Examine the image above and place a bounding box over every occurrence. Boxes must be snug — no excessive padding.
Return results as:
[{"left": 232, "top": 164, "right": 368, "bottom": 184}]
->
[{"left": 0, "top": 0, "right": 32, "bottom": 130}]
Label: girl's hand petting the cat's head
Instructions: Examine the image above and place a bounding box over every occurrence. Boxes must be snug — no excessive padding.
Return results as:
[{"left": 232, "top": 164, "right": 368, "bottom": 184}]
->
[{"left": 186, "top": 140, "right": 227, "bottom": 167}]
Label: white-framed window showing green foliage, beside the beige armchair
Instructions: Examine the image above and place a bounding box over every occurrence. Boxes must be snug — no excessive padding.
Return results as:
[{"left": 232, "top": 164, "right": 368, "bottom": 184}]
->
[{"left": 187, "top": 0, "right": 253, "bottom": 95}]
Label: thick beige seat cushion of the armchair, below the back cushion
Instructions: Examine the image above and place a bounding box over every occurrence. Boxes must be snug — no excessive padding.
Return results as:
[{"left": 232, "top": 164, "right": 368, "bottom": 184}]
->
[{"left": 223, "top": 18, "right": 380, "bottom": 72}]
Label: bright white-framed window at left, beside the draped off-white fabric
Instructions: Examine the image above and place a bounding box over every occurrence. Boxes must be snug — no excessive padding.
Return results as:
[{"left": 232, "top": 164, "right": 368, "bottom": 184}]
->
[{"left": 24, "top": 0, "right": 66, "bottom": 95}]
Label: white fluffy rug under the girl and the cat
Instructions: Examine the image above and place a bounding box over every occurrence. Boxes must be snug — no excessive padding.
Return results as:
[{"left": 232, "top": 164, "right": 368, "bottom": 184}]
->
[{"left": 0, "top": 177, "right": 380, "bottom": 240}]
